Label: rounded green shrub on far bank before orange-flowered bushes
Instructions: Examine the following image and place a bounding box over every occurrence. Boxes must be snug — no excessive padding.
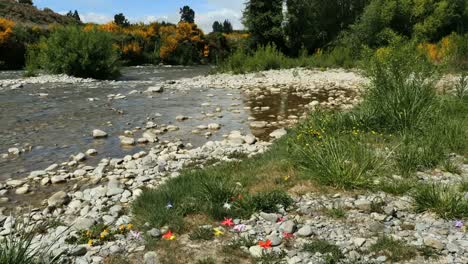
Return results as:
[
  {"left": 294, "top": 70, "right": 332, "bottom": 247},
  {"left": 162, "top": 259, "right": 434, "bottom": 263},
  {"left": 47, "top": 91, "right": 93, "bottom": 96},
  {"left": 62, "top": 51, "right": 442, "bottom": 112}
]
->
[{"left": 27, "top": 27, "right": 120, "bottom": 79}]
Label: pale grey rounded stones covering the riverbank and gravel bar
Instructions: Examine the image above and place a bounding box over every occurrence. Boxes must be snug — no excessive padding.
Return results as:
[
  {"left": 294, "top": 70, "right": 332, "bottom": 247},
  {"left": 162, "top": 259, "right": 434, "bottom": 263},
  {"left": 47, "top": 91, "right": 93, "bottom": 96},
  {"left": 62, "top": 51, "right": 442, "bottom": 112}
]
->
[{"left": 0, "top": 69, "right": 468, "bottom": 264}]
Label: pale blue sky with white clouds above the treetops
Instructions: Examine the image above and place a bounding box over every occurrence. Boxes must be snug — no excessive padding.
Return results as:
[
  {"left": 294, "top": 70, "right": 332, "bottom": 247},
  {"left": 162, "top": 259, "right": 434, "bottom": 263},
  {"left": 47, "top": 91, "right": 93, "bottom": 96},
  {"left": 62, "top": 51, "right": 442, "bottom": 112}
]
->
[{"left": 33, "top": 0, "right": 244, "bottom": 32}]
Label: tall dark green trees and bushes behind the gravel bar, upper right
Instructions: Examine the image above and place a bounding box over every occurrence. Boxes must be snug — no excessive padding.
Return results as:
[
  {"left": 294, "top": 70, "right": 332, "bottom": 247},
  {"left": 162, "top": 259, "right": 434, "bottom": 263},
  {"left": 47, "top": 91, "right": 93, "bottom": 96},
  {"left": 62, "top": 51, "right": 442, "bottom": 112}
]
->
[{"left": 218, "top": 0, "right": 468, "bottom": 73}]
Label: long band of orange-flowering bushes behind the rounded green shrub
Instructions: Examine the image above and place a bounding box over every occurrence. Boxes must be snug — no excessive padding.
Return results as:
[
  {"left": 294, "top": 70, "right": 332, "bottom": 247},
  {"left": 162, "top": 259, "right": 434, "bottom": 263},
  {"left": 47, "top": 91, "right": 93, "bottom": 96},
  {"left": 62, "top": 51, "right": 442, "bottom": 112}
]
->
[{"left": 0, "top": 3, "right": 249, "bottom": 78}]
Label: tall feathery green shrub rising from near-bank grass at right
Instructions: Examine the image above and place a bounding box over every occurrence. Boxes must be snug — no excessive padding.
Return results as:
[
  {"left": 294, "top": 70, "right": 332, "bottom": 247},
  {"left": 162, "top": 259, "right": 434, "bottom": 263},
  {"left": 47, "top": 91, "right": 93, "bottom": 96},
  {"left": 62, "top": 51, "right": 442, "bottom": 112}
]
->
[{"left": 363, "top": 44, "right": 438, "bottom": 132}]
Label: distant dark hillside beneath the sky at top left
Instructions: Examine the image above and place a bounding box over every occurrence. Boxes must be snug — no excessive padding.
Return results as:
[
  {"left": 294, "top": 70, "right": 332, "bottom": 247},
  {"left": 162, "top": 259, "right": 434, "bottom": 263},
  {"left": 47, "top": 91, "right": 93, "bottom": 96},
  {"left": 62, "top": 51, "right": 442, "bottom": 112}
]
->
[{"left": 0, "top": 0, "right": 77, "bottom": 25}]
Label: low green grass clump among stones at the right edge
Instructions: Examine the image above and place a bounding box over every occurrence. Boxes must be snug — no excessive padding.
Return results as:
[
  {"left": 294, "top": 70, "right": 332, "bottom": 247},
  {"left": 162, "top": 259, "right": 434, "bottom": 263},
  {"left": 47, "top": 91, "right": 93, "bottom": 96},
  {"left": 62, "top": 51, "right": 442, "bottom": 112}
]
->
[{"left": 413, "top": 184, "right": 468, "bottom": 219}]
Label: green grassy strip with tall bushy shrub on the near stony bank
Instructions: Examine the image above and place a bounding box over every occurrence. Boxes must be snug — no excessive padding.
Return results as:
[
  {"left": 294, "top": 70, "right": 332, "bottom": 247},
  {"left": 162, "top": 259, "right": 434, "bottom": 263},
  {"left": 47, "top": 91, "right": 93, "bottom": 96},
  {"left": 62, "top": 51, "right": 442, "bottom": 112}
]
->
[{"left": 133, "top": 41, "right": 468, "bottom": 232}]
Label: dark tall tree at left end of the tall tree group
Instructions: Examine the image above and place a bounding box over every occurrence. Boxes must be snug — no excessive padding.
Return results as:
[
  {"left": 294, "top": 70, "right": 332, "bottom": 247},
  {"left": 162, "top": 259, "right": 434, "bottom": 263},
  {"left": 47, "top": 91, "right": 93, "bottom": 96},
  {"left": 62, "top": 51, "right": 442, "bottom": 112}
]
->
[{"left": 243, "top": 0, "right": 284, "bottom": 50}]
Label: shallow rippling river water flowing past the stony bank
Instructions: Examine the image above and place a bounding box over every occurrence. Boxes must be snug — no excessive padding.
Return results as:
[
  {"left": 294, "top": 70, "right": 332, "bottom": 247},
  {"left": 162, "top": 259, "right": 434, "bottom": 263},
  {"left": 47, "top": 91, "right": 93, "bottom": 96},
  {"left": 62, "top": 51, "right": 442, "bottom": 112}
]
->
[{"left": 0, "top": 66, "right": 318, "bottom": 184}]
